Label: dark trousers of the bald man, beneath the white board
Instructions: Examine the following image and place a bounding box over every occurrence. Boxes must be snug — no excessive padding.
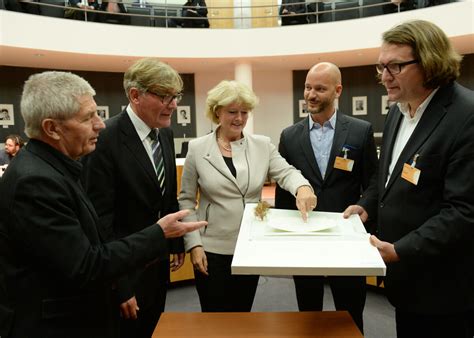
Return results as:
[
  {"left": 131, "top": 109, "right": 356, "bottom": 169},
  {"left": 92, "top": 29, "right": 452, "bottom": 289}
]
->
[{"left": 293, "top": 276, "right": 367, "bottom": 333}]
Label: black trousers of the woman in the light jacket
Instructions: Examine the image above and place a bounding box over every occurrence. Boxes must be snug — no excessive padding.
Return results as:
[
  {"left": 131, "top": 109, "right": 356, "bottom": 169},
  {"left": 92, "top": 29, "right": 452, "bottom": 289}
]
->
[{"left": 195, "top": 252, "right": 259, "bottom": 312}]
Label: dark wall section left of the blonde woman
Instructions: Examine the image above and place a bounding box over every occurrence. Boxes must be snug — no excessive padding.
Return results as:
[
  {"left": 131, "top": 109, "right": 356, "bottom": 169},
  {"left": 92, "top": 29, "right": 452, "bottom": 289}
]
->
[{"left": 0, "top": 66, "right": 196, "bottom": 143}]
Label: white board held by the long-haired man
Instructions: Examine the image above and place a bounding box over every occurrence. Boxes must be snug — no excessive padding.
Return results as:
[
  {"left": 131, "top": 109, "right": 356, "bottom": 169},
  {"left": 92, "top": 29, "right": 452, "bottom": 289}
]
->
[{"left": 232, "top": 203, "right": 386, "bottom": 276}]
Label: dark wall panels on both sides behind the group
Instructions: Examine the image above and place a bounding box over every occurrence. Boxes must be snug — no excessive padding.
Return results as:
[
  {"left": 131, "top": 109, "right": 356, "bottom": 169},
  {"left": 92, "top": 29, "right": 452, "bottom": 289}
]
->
[{"left": 0, "top": 54, "right": 474, "bottom": 143}]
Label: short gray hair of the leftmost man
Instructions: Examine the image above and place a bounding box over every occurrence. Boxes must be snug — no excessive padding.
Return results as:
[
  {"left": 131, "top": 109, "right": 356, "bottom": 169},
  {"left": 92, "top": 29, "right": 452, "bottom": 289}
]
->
[{"left": 20, "top": 71, "right": 95, "bottom": 138}]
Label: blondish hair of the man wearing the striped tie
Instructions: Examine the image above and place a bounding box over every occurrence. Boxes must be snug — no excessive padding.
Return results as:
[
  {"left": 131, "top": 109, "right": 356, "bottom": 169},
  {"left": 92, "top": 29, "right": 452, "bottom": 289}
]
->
[{"left": 123, "top": 58, "right": 183, "bottom": 99}]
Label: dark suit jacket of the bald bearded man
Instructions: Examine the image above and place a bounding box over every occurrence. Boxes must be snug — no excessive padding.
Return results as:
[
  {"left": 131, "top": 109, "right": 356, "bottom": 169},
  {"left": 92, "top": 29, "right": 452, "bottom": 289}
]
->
[{"left": 275, "top": 112, "right": 377, "bottom": 230}]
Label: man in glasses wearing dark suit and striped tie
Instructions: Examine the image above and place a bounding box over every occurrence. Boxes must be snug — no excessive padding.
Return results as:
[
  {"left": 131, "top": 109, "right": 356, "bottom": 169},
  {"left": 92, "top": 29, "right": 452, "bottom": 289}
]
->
[{"left": 83, "top": 58, "right": 184, "bottom": 338}]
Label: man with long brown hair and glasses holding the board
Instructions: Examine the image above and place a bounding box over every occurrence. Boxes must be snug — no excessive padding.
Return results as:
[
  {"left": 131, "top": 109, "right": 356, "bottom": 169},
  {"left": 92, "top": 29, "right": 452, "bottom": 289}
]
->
[{"left": 345, "top": 20, "right": 474, "bottom": 338}]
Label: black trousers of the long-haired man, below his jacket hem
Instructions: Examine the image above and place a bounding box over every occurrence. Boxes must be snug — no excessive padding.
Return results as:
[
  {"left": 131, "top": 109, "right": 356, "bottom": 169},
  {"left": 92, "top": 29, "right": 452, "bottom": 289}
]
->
[{"left": 395, "top": 309, "right": 472, "bottom": 338}]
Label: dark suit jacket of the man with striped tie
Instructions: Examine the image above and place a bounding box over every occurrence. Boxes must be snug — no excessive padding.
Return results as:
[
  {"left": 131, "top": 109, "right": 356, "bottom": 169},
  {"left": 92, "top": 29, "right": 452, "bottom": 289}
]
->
[{"left": 83, "top": 111, "right": 184, "bottom": 309}]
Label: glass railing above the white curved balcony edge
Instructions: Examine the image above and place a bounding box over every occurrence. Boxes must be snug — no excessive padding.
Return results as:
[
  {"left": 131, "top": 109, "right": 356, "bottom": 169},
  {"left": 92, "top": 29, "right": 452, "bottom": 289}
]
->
[{"left": 0, "top": 0, "right": 454, "bottom": 28}]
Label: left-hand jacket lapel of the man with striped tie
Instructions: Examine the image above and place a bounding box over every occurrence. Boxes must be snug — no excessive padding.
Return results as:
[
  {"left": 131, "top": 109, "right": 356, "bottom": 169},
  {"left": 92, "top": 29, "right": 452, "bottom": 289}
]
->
[{"left": 119, "top": 112, "right": 160, "bottom": 191}]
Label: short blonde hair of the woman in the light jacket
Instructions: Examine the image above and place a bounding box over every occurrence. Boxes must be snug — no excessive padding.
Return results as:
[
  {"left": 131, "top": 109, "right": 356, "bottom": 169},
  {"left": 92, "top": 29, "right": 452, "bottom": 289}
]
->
[{"left": 206, "top": 80, "right": 258, "bottom": 124}]
